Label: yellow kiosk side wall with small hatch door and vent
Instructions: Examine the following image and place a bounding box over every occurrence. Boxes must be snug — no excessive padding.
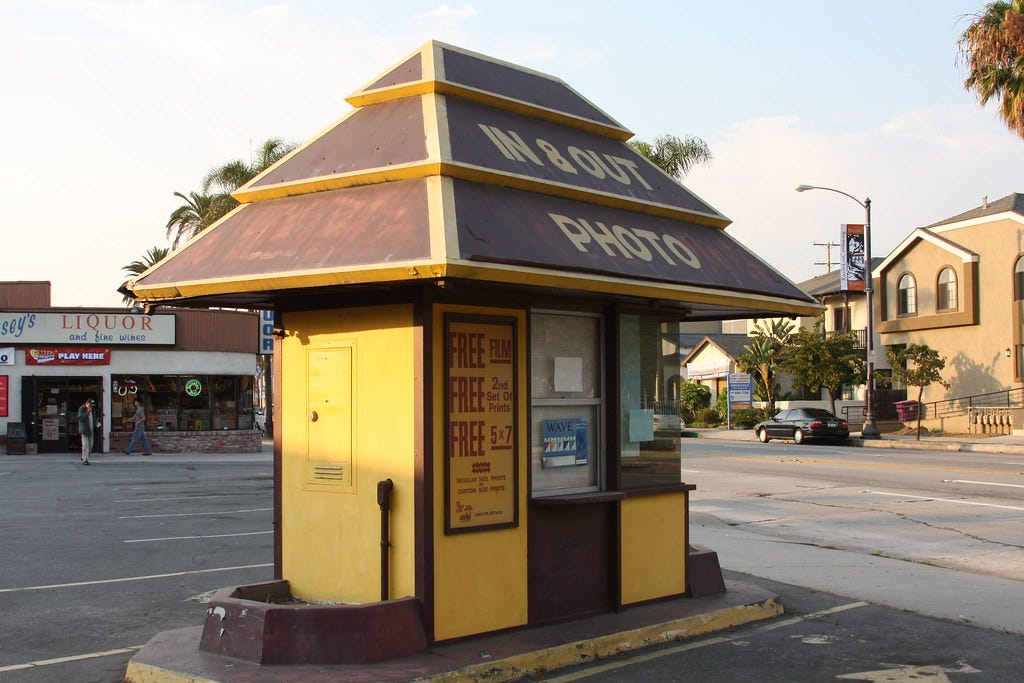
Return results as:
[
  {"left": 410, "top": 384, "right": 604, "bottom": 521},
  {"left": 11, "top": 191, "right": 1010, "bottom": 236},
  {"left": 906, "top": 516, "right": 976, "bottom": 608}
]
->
[{"left": 282, "top": 305, "right": 422, "bottom": 603}]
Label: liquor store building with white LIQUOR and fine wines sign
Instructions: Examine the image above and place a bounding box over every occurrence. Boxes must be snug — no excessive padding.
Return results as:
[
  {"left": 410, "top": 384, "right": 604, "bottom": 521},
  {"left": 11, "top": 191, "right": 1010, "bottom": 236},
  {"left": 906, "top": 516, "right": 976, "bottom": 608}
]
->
[{"left": 0, "top": 282, "right": 262, "bottom": 454}]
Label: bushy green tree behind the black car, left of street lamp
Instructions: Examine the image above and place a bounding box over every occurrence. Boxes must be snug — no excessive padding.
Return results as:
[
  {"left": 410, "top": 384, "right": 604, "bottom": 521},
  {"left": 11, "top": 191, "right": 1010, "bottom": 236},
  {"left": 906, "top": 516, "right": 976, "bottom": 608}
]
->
[{"left": 781, "top": 319, "right": 867, "bottom": 414}]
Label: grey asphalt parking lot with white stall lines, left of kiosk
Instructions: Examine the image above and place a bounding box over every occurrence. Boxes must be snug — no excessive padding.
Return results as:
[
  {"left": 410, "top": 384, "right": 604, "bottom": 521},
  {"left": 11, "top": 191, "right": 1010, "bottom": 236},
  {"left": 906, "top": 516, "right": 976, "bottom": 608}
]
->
[{"left": 0, "top": 455, "right": 273, "bottom": 683}]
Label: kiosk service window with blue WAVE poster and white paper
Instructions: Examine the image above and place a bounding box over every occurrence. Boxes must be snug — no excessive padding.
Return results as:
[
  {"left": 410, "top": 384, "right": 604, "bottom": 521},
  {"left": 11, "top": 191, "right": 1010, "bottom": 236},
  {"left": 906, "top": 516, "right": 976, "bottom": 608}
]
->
[{"left": 530, "top": 311, "right": 604, "bottom": 498}]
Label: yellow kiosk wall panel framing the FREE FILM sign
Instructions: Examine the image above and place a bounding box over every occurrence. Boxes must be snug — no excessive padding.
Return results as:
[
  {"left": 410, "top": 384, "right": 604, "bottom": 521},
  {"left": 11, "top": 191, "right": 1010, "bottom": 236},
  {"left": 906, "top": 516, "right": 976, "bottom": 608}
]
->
[{"left": 433, "top": 306, "right": 529, "bottom": 640}]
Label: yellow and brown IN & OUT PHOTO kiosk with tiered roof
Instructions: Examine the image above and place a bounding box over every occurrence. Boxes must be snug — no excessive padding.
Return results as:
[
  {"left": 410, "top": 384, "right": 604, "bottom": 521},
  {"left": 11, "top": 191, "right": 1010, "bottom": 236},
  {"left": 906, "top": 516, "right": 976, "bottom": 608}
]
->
[{"left": 128, "top": 42, "right": 820, "bottom": 656}]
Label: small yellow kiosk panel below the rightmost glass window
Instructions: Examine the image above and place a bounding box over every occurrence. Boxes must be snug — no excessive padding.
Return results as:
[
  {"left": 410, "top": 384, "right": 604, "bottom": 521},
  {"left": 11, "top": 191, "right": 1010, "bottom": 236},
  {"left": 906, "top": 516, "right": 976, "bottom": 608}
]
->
[{"left": 620, "top": 493, "right": 688, "bottom": 605}]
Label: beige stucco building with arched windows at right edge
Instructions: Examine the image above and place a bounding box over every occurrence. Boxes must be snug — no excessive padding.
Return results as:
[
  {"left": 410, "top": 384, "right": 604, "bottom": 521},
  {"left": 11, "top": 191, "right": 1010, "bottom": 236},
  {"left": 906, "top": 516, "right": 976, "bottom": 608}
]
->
[{"left": 873, "top": 194, "right": 1024, "bottom": 402}]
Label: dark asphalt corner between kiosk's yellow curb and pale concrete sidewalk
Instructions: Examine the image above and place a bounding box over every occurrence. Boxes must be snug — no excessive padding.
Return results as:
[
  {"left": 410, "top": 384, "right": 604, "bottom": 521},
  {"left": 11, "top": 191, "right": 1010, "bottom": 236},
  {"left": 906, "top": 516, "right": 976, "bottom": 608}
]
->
[{"left": 527, "top": 572, "right": 1024, "bottom": 683}]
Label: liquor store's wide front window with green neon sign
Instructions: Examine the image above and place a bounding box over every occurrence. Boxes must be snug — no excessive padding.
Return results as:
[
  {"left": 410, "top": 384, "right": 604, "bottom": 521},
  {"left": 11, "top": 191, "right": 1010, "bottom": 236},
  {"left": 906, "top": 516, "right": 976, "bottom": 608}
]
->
[{"left": 111, "top": 375, "right": 253, "bottom": 431}]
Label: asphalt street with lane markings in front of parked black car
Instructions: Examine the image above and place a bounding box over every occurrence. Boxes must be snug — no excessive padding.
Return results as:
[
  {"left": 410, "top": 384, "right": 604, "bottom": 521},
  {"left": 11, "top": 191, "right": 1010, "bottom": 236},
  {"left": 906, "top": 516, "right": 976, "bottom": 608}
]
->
[{"left": 683, "top": 440, "right": 1024, "bottom": 581}]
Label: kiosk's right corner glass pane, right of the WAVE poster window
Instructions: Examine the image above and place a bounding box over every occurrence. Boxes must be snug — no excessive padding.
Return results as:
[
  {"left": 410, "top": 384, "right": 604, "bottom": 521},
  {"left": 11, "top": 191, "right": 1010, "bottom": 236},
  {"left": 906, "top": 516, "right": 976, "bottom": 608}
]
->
[{"left": 618, "top": 315, "right": 682, "bottom": 489}]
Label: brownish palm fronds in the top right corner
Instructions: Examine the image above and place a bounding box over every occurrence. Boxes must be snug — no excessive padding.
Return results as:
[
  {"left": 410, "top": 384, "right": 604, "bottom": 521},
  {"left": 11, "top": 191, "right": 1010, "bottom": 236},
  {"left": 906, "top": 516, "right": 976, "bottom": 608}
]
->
[{"left": 957, "top": 0, "right": 1024, "bottom": 137}]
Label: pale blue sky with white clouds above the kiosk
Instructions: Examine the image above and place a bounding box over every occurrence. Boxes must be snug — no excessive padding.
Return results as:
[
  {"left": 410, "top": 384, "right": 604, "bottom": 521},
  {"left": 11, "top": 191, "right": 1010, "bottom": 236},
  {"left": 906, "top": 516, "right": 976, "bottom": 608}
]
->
[{"left": 0, "top": 0, "right": 1024, "bottom": 306}]
